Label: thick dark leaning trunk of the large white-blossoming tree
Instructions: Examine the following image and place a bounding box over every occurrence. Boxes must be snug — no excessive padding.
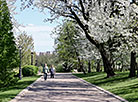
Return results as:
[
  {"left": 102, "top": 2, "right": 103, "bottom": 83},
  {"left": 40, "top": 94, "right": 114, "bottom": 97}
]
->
[{"left": 70, "top": 8, "right": 115, "bottom": 77}]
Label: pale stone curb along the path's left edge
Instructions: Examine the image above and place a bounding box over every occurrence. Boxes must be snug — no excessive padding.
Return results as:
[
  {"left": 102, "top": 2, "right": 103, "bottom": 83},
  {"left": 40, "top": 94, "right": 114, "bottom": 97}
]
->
[{"left": 9, "top": 76, "right": 42, "bottom": 102}]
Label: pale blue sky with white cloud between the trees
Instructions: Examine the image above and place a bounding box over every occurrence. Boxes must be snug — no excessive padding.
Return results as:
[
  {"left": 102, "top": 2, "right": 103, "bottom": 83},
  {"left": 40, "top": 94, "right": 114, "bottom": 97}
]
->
[{"left": 14, "top": 2, "right": 57, "bottom": 52}]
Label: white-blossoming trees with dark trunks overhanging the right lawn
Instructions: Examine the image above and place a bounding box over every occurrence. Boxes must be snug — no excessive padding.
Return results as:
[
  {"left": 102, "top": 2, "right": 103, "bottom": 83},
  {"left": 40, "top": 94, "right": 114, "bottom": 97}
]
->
[{"left": 20, "top": 0, "right": 138, "bottom": 77}]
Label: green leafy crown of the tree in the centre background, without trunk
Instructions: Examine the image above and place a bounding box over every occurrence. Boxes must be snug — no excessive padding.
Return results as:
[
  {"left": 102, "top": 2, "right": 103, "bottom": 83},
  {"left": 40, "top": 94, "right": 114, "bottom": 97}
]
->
[{"left": 56, "top": 21, "right": 79, "bottom": 61}]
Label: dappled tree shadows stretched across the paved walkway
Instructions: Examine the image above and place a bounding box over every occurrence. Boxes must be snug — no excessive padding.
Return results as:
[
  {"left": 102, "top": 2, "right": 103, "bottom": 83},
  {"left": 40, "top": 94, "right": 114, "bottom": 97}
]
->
[{"left": 15, "top": 73, "right": 125, "bottom": 102}]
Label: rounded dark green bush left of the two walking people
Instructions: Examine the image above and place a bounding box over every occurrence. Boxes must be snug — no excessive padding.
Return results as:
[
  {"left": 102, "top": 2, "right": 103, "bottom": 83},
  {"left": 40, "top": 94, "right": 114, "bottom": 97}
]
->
[{"left": 22, "top": 65, "right": 38, "bottom": 76}]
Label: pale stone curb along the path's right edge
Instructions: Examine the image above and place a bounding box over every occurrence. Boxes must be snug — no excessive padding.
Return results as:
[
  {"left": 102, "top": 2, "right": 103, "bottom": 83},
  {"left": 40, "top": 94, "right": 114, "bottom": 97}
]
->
[{"left": 72, "top": 74, "right": 128, "bottom": 102}]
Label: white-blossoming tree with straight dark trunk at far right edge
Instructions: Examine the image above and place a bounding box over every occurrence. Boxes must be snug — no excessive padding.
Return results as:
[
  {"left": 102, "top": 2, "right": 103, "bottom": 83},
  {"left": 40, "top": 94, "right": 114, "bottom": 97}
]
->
[{"left": 107, "top": 0, "right": 138, "bottom": 77}]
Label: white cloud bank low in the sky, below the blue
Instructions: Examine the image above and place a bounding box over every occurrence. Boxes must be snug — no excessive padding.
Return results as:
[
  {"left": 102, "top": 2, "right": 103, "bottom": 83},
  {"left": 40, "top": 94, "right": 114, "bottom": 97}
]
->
[{"left": 17, "top": 24, "right": 54, "bottom": 52}]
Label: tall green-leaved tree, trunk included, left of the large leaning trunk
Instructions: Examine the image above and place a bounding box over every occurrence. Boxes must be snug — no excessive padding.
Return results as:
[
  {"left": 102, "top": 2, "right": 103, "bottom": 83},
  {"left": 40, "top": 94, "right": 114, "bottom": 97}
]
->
[{"left": 56, "top": 21, "right": 85, "bottom": 73}]
